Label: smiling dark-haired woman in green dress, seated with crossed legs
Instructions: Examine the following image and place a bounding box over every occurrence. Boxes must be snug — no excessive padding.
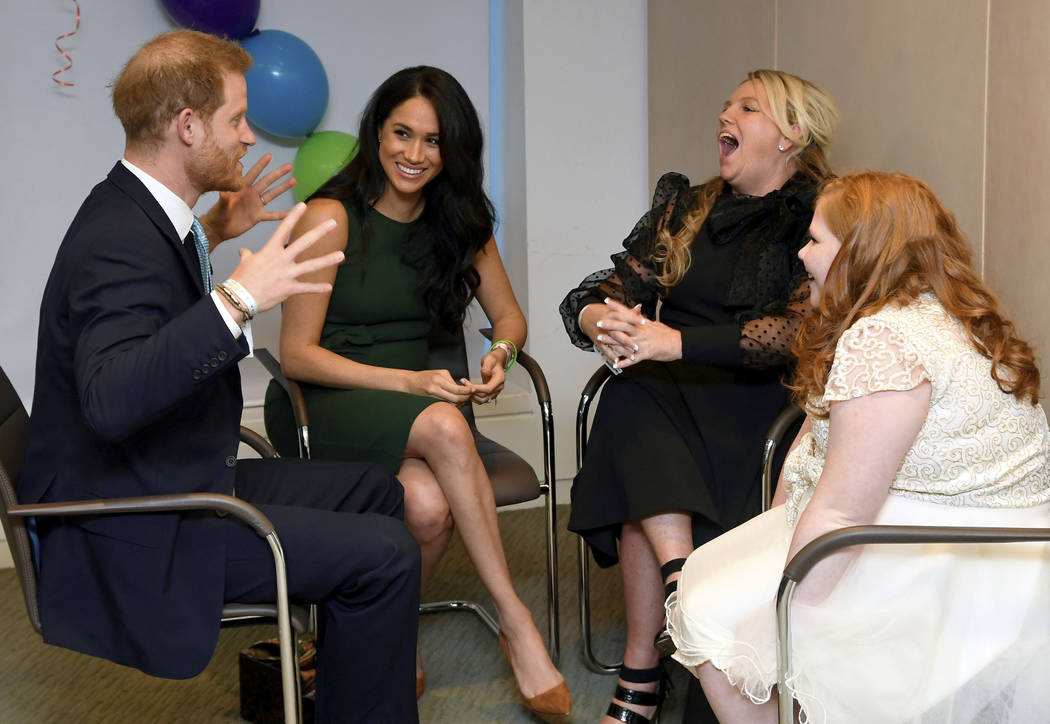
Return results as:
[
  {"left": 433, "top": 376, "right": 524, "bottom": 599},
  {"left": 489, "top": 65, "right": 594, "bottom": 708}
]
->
[{"left": 266, "top": 66, "right": 570, "bottom": 714}]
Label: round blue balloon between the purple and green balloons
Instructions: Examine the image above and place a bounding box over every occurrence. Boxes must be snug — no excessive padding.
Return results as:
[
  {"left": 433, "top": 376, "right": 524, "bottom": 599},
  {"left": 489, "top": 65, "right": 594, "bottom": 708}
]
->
[{"left": 240, "top": 30, "right": 328, "bottom": 139}]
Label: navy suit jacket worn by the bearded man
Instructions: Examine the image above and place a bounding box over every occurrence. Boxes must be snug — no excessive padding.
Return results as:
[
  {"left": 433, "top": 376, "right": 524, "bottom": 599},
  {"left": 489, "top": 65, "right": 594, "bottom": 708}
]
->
[{"left": 19, "top": 164, "right": 248, "bottom": 678}]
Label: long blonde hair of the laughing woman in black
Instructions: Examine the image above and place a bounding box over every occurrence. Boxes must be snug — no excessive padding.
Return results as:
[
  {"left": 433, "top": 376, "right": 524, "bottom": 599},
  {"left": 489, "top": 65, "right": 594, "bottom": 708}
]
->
[{"left": 652, "top": 69, "right": 839, "bottom": 288}]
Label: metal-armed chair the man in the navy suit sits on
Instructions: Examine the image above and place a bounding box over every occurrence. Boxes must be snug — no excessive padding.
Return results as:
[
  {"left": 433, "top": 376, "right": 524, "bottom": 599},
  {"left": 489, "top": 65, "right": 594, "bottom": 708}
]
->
[{"left": 0, "top": 369, "right": 307, "bottom": 724}]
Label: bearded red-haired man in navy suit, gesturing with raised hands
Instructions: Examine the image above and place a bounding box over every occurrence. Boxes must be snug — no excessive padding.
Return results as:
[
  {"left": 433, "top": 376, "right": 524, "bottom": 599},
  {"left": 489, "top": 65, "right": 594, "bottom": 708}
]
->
[{"left": 19, "top": 30, "right": 420, "bottom": 722}]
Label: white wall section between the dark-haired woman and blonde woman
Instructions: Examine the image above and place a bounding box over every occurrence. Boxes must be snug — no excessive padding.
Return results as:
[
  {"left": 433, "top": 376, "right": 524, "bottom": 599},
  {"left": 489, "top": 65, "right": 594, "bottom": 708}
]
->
[{"left": 524, "top": 0, "right": 648, "bottom": 486}]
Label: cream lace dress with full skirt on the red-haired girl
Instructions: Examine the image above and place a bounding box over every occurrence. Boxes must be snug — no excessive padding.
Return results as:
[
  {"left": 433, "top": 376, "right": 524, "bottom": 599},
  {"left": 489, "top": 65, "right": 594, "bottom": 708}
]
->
[{"left": 667, "top": 294, "right": 1050, "bottom": 724}]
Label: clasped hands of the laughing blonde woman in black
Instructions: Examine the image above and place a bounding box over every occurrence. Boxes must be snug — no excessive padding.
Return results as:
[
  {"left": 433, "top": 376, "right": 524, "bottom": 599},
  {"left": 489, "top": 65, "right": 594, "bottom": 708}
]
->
[{"left": 594, "top": 299, "right": 681, "bottom": 368}]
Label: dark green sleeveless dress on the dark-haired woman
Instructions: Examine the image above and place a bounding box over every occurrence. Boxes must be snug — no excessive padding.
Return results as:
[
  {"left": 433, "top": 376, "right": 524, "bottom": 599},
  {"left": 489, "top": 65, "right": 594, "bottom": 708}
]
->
[{"left": 264, "top": 208, "right": 437, "bottom": 473}]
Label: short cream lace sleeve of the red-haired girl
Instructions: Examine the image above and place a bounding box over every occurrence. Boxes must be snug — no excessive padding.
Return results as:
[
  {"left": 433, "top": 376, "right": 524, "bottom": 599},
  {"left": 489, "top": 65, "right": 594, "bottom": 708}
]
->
[{"left": 822, "top": 321, "right": 930, "bottom": 407}]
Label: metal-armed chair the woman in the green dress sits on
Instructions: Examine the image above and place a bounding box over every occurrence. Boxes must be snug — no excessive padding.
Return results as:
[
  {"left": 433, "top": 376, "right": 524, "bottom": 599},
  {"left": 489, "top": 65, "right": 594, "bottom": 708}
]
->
[{"left": 255, "top": 329, "right": 561, "bottom": 664}]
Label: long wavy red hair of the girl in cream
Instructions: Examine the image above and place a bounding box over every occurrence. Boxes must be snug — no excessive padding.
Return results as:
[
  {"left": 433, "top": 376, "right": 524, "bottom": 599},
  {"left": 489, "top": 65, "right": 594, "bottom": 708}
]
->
[{"left": 790, "top": 171, "right": 1040, "bottom": 411}]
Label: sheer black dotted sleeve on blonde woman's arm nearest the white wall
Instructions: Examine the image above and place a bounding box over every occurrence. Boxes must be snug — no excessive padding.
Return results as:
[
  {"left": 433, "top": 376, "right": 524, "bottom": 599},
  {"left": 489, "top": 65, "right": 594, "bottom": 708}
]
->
[{"left": 559, "top": 173, "right": 689, "bottom": 349}]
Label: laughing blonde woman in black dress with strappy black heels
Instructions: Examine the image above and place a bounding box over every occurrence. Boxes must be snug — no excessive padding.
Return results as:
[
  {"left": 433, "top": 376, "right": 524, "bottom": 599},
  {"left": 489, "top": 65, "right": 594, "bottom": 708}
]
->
[{"left": 561, "top": 70, "right": 838, "bottom": 724}]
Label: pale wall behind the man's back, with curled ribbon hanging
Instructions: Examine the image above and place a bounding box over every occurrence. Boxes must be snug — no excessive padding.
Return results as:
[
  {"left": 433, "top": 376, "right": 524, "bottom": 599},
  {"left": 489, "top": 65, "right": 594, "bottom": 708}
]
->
[{"left": 0, "top": 0, "right": 170, "bottom": 405}]
